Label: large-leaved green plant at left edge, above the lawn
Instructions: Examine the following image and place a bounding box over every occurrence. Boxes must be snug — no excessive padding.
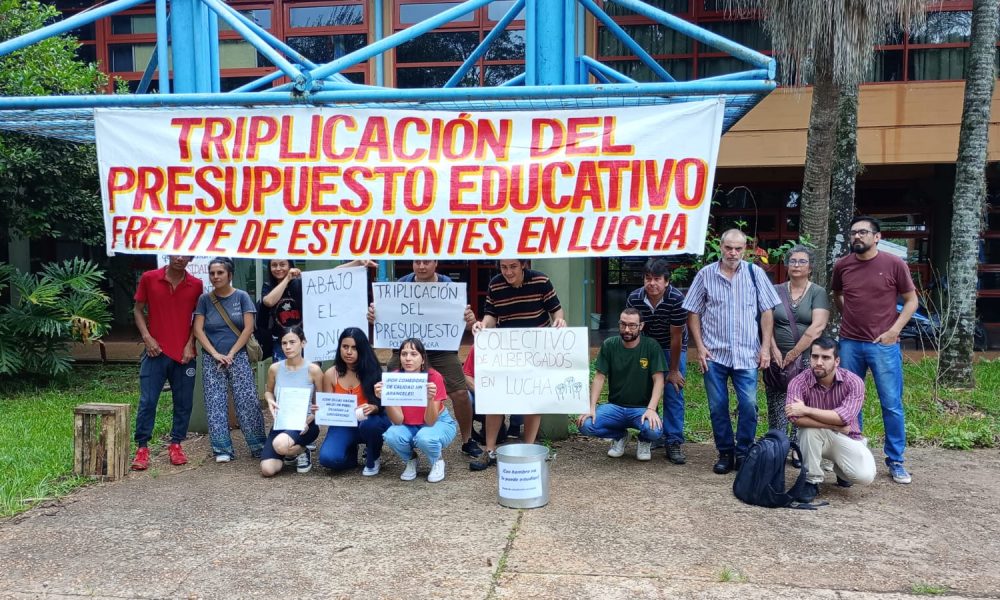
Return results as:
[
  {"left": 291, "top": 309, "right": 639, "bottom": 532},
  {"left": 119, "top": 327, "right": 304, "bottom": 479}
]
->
[{"left": 0, "top": 258, "right": 111, "bottom": 377}]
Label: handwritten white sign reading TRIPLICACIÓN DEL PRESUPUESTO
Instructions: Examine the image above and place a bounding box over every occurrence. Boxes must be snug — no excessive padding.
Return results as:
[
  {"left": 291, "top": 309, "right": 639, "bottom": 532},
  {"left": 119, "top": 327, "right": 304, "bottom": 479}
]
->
[{"left": 372, "top": 282, "right": 467, "bottom": 350}]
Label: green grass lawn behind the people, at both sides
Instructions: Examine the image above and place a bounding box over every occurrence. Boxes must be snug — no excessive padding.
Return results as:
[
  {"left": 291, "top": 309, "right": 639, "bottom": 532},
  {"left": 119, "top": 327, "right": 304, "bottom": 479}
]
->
[{"left": 0, "top": 359, "right": 1000, "bottom": 517}]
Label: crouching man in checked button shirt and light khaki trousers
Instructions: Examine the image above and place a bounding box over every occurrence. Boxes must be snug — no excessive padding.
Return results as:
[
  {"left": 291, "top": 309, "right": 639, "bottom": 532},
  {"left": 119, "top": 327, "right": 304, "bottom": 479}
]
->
[{"left": 785, "top": 336, "right": 875, "bottom": 502}]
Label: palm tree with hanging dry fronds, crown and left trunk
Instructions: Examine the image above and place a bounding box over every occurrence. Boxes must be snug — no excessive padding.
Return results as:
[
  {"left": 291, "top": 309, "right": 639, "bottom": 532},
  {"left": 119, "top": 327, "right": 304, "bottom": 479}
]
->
[{"left": 727, "top": 0, "right": 928, "bottom": 286}]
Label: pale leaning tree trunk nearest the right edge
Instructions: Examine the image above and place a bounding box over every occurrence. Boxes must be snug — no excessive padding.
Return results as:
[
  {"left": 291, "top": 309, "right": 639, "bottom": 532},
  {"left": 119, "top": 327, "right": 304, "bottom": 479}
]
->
[{"left": 938, "top": 0, "right": 1000, "bottom": 388}]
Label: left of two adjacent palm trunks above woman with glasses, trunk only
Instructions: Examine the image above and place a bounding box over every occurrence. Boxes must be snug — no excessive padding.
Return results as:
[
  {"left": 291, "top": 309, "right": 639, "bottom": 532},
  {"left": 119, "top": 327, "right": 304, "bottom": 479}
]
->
[{"left": 799, "top": 46, "right": 840, "bottom": 287}]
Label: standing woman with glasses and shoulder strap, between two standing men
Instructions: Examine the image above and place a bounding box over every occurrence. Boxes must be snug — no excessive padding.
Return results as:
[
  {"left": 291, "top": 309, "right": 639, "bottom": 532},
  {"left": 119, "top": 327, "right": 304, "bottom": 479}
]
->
[{"left": 764, "top": 245, "right": 830, "bottom": 454}]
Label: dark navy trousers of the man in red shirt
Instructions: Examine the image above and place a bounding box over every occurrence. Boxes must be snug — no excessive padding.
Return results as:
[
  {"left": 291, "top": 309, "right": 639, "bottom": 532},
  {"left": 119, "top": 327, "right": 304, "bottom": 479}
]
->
[{"left": 135, "top": 352, "right": 196, "bottom": 448}]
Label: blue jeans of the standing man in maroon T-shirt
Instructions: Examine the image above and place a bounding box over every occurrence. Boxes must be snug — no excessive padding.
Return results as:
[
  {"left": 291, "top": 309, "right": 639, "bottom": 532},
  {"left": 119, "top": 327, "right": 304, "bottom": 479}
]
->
[{"left": 840, "top": 338, "right": 906, "bottom": 462}]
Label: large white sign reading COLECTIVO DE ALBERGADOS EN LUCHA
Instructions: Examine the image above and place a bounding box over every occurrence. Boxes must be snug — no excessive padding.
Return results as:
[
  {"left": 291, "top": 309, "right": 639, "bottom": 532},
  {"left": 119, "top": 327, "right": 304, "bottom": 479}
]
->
[{"left": 474, "top": 327, "right": 590, "bottom": 415}]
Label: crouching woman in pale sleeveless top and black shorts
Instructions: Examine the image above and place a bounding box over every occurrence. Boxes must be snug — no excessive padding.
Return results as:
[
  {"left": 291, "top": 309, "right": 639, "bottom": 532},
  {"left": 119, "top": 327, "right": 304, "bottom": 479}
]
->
[{"left": 260, "top": 325, "right": 323, "bottom": 477}]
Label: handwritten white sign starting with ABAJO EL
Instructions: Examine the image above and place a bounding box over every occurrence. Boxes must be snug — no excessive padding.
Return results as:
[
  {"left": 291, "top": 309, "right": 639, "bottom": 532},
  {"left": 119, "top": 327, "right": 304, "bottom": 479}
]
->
[{"left": 302, "top": 267, "right": 368, "bottom": 362}]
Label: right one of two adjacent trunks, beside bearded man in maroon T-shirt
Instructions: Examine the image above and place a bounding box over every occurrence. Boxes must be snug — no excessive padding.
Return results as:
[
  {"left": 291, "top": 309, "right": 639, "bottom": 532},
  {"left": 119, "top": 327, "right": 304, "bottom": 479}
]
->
[{"left": 826, "top": 85, "right": 859, "bottom": 336}]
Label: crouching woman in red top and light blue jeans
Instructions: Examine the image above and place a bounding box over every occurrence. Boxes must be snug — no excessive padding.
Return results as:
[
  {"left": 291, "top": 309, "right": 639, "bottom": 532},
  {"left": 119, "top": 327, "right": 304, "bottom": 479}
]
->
[{"left": 375, "top": 338, "right": 457, "bottom": 483}]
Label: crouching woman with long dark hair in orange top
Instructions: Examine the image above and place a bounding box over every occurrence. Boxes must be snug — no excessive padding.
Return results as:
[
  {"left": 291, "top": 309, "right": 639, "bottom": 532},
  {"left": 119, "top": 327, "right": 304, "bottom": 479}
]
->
[{"left": 319, "top": 327, "right": 392, "bottom": 477}]
